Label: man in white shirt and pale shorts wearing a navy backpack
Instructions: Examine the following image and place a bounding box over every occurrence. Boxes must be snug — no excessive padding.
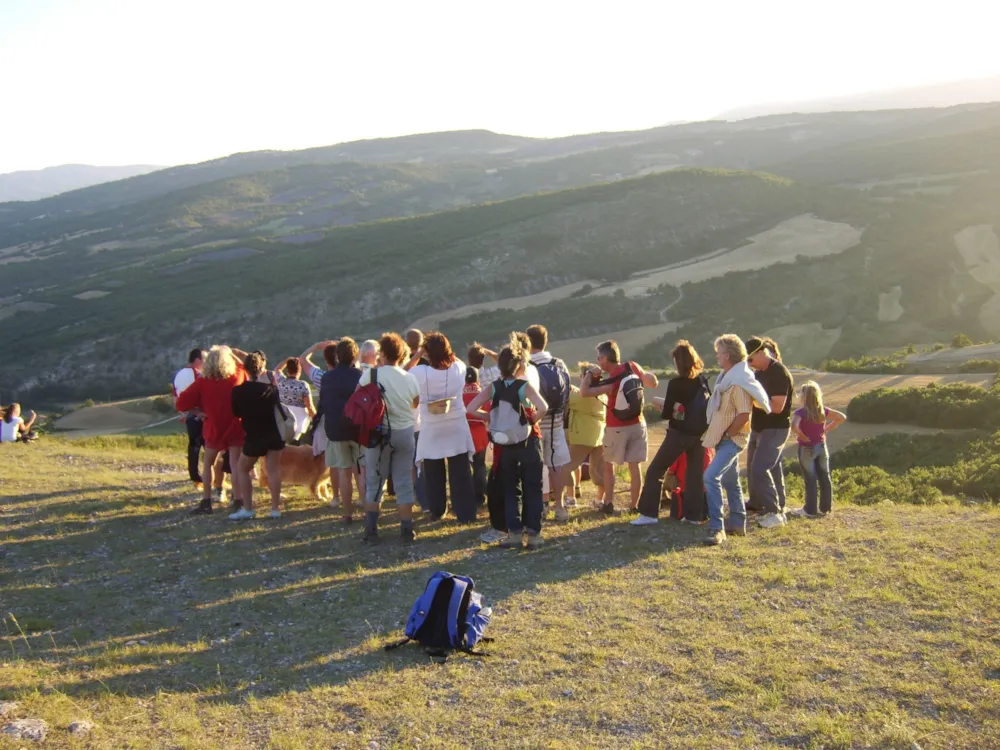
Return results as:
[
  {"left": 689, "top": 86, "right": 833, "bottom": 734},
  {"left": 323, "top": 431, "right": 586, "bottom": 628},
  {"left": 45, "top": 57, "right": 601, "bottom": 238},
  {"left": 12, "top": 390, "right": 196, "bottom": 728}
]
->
[{"left": 526, "top": 325, "right": 570, "bottom": 521}]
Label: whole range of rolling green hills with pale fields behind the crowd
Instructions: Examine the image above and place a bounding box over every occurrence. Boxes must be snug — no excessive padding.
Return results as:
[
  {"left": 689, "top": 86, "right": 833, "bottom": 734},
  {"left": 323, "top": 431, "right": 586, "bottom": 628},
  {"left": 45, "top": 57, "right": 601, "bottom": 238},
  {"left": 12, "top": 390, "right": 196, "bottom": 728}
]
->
[{"left": 0, "top": 105, "right": 1000, "bottom": 400}]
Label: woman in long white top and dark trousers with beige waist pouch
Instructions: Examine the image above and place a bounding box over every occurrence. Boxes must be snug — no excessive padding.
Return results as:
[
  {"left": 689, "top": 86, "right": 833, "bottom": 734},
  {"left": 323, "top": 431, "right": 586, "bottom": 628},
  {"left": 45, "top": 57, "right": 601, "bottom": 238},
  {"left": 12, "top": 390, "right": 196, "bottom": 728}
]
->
[{"left": 410, "top": 331, "right": 476, "bottom": 523}]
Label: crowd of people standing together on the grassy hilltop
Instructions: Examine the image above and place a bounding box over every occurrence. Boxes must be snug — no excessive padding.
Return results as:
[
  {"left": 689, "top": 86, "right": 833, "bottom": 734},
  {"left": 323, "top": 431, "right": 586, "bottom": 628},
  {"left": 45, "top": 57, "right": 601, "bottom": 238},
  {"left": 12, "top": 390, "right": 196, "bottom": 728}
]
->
[{"left": 170, "top": 325, "right": 845, "bottom": 548}]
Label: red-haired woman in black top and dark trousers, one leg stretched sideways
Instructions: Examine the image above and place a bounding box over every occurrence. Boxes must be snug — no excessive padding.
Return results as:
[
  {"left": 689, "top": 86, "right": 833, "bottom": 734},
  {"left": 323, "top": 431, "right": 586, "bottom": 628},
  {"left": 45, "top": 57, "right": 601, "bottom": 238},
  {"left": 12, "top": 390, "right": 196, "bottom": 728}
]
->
[{"left": 632, "top": 340, "right": 710, "bottom": 526}]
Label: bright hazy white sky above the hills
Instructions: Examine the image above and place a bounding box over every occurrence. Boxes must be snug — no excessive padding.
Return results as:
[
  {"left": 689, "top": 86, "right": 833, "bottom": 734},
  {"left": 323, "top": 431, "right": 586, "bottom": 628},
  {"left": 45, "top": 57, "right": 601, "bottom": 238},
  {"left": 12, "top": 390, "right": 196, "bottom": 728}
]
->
[{"left": 0, "top": 0, "right": 1000, "bottom": 172}]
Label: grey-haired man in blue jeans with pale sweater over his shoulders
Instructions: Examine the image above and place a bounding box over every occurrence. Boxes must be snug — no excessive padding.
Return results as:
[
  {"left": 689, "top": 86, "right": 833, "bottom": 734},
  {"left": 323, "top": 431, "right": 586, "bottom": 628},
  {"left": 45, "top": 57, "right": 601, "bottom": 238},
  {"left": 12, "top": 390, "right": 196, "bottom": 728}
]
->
[{"left": 701, "top": 333, "right": 771, "bottom": 545}]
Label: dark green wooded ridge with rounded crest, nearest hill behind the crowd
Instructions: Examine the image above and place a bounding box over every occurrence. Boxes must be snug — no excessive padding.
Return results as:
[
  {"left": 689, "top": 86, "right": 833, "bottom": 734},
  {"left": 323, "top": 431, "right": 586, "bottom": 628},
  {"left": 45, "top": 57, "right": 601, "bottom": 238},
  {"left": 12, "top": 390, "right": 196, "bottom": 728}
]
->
[{"left": 0, "top": 171, "right": 866, "bottom": 400}]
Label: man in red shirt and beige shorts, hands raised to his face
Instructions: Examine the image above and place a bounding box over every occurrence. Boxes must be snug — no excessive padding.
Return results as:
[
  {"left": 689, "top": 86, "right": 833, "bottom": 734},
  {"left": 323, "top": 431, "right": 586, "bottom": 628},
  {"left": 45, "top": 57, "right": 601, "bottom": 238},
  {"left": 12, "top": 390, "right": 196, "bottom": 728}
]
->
[{"left": 580, "top": 340, "right": 659, "bottom": 515}]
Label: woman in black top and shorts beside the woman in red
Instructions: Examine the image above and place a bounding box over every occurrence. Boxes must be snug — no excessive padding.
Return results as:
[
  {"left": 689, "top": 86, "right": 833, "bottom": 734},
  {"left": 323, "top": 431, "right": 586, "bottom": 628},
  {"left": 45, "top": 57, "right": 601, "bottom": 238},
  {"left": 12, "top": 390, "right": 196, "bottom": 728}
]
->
[{"left": 229, "top": 352, "right": 285, "bottom": 521}]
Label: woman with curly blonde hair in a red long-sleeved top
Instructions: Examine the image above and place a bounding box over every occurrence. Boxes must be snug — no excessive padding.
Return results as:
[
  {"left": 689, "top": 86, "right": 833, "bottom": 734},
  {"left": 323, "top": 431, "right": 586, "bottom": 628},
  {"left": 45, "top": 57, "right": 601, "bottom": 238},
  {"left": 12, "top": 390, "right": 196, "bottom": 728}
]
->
[{"left": 174, "top": 346, "right": 247, "bottom": 515}]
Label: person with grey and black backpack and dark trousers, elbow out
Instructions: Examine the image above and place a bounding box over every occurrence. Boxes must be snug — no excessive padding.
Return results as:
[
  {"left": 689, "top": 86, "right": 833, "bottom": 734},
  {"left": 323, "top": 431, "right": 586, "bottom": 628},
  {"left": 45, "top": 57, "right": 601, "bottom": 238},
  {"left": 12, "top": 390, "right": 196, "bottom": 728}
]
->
[{"left": 466, "top": 336, "right": 548, "bottom": 549}]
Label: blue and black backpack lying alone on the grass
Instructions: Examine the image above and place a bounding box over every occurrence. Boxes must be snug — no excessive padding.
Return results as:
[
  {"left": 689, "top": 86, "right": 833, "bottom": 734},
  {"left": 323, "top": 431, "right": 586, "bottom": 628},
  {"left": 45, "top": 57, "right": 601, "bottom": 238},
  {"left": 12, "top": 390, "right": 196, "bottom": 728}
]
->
[{"left": 385, "top": 571, "right": 493, "bottom": 656}]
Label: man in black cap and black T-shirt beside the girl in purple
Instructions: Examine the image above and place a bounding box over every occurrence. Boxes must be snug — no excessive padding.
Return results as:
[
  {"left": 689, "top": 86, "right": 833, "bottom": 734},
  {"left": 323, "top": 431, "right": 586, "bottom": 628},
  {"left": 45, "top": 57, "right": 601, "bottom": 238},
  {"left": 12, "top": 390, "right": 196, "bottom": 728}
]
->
[{"left": 746, "top": 336, "right": 794, "bottom": 529}]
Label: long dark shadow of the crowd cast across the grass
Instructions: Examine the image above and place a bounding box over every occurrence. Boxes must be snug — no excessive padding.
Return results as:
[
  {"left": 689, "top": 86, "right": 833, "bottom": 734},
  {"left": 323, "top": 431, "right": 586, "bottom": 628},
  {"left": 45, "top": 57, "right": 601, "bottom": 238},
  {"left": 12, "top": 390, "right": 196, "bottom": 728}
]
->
[{"left": 0, "top": 494, "right": 704, "bottom": 703}]
